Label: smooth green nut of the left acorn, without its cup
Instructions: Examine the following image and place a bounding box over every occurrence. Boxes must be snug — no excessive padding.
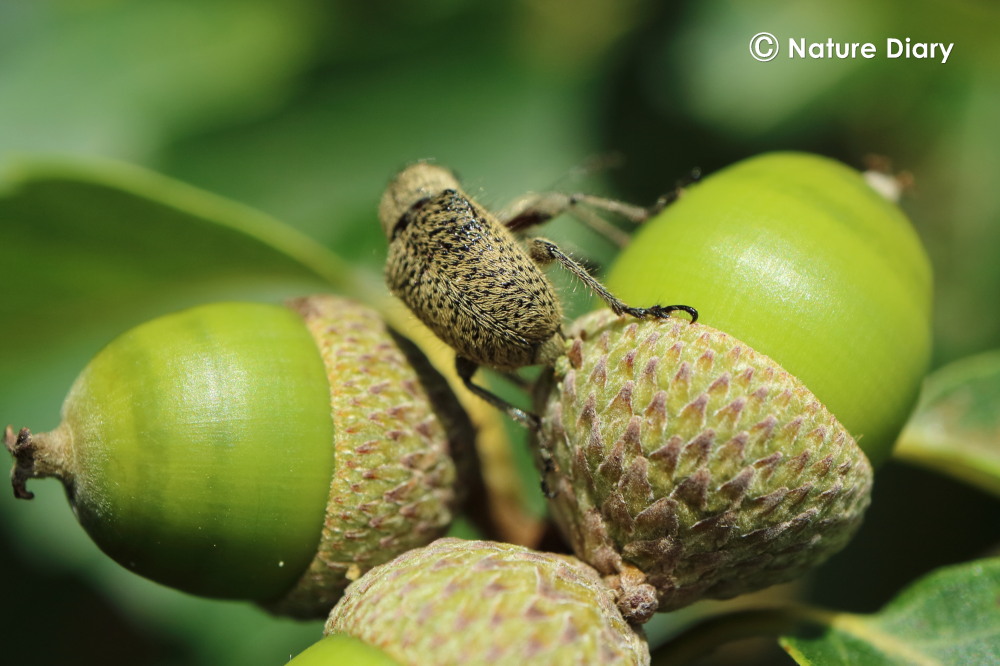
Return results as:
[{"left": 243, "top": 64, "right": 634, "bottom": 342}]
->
[{"left": 60, "top": 303, "right": 334, "bottom": 600}]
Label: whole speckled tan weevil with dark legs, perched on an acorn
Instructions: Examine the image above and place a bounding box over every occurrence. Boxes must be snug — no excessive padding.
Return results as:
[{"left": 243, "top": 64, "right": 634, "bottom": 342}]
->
[{"left": 379, "top": 162, "right": 698, "bottom": 427}]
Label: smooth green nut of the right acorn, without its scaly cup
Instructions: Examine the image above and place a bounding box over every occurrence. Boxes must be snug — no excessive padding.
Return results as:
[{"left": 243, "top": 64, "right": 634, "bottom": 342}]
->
[{"left": 606, "top": 153, "right": 932, "bottom": 464}]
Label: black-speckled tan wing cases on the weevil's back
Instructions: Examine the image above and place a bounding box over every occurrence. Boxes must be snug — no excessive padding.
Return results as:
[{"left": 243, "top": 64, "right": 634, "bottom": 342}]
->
[{"left": 386, "top": 189, "right": 562, "bottom": 370}]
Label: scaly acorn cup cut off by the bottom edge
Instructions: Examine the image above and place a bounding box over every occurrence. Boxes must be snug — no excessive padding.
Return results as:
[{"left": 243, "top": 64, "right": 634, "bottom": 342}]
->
[{"left": 325, "top": 538, "right": 649, "bottom": 666}]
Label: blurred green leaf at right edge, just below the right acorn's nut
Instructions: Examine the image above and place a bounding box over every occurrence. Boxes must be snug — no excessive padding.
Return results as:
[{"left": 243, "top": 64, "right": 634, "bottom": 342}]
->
[{"left": 895, "top": 350, "right": 1000, "bottom": 495}]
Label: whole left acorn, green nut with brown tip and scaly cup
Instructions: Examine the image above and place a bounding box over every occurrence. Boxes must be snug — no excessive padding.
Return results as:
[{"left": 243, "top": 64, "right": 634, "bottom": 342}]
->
[{"left": 5, "top": 296, "right": 468, "bottom": 617}]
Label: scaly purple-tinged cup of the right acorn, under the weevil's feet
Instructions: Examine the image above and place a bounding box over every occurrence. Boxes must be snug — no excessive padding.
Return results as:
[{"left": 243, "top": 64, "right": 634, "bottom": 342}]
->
[{"left": 536, "top": 310, "right": 872, "bottom": 622}]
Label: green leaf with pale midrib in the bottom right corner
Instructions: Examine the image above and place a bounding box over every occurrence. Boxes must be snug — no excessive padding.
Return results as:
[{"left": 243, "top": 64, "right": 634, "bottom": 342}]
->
[{"left": 780, "top": 558, "right": 1000, "bottom": 666}]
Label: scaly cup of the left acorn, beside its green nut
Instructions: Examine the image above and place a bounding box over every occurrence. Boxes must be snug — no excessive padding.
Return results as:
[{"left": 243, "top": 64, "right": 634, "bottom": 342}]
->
[{"left": 267, "top": 296, "right": 473, "bottom": 617}]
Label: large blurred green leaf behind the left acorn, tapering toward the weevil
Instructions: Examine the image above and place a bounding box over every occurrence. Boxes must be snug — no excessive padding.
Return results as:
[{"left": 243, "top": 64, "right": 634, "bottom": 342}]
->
[{"left": 0, "top": 153, "right": 377, "bottom": 428}]
